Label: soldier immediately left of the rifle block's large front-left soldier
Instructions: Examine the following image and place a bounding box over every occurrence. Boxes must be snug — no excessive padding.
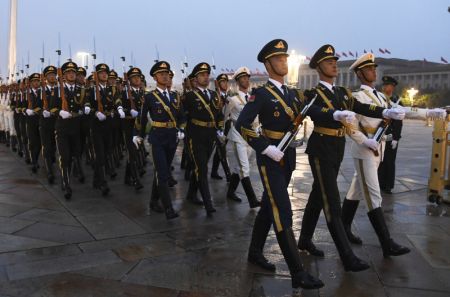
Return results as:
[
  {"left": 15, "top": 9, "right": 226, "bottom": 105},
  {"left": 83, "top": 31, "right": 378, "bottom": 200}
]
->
[{"left": 39, "top": 65, "right": 60, "bottom": 184}]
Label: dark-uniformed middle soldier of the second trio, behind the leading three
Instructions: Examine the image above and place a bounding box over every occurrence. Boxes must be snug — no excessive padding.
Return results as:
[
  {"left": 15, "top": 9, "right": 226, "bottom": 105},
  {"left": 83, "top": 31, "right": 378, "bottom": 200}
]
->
[{"left": 183, "top": 62, "right": 225, "bottom": 216}]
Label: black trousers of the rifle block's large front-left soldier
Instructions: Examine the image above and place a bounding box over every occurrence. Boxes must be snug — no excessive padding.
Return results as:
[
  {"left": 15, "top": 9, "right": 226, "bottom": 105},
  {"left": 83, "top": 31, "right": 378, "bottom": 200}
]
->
[{"left": 55, "top": 117, "right": 81, "bottom": 169}]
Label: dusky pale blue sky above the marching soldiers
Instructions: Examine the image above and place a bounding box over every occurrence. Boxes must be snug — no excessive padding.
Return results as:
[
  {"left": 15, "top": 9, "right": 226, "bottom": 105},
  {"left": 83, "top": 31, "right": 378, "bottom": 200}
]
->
[{"left": 0, "top": 0, "right": 450, "bottom": 82}]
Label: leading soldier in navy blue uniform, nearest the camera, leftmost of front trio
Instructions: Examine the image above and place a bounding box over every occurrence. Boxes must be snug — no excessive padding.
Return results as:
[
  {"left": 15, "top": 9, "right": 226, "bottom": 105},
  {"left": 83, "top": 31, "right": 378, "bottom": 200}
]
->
[{"left": 236, "top": 39, "right": 333, "bottom": 289}]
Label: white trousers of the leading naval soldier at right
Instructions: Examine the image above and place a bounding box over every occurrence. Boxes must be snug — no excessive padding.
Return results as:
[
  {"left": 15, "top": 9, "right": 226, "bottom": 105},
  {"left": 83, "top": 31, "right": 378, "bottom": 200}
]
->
[{"left": 347, "top": 158, "right": 382, "bottom": 211}]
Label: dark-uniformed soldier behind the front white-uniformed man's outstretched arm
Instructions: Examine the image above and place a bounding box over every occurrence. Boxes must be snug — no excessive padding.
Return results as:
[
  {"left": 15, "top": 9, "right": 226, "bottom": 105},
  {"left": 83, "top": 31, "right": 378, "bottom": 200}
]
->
[{"left": 378, "top": 76, "right": 403, "bottom": 194}]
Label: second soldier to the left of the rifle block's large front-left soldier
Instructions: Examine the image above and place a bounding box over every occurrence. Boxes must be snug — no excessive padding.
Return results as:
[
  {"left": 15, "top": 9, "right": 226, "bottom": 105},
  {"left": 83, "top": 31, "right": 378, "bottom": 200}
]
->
[{"left": 25, "top": 73, "right": 42, "bottom": 173}]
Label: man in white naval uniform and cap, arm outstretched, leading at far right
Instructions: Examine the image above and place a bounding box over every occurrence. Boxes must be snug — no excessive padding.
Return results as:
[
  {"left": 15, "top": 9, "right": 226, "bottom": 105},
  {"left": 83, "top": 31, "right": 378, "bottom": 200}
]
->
[{"left": 342, "top": 53, "right": 445, "bottom": 257}]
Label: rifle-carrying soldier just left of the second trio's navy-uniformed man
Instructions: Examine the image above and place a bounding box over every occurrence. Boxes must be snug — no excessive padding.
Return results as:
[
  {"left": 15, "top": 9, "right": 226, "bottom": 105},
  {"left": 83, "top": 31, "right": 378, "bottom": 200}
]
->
[{"left": 118, "top": 67, "right": 144, "bottom": 190}]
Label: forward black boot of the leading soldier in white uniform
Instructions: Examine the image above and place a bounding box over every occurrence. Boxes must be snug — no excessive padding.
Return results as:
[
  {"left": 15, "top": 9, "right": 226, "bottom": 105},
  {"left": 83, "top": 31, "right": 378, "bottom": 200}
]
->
[{"left": 367, "top": 207, "right": 411, "bottom": 258}]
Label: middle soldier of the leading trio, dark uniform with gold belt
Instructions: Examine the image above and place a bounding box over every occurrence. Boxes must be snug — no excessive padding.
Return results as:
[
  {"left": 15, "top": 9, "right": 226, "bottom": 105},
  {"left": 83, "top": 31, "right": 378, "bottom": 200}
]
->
[{"left": 298, "top": 44, "right": 396, "bottom": 271}]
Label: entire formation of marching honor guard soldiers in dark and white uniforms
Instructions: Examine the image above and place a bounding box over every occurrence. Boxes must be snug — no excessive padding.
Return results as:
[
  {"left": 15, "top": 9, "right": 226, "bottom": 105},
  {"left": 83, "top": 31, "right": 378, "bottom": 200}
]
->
[{"left": 0, "top": 39, "right": 446, "bottom": 289}]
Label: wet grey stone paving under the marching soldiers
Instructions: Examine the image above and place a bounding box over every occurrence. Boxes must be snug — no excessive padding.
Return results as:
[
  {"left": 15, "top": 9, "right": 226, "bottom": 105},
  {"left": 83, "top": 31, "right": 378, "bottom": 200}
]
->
[{"left": 0, "top": 121, "right": 450, "bottom": 297}]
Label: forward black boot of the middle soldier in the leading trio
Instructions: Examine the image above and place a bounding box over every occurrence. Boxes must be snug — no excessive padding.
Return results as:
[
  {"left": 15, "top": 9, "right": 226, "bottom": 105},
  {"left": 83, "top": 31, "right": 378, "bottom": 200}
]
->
[{"left": 327, "top": 218, "right": 370, "bottom": 272}]
